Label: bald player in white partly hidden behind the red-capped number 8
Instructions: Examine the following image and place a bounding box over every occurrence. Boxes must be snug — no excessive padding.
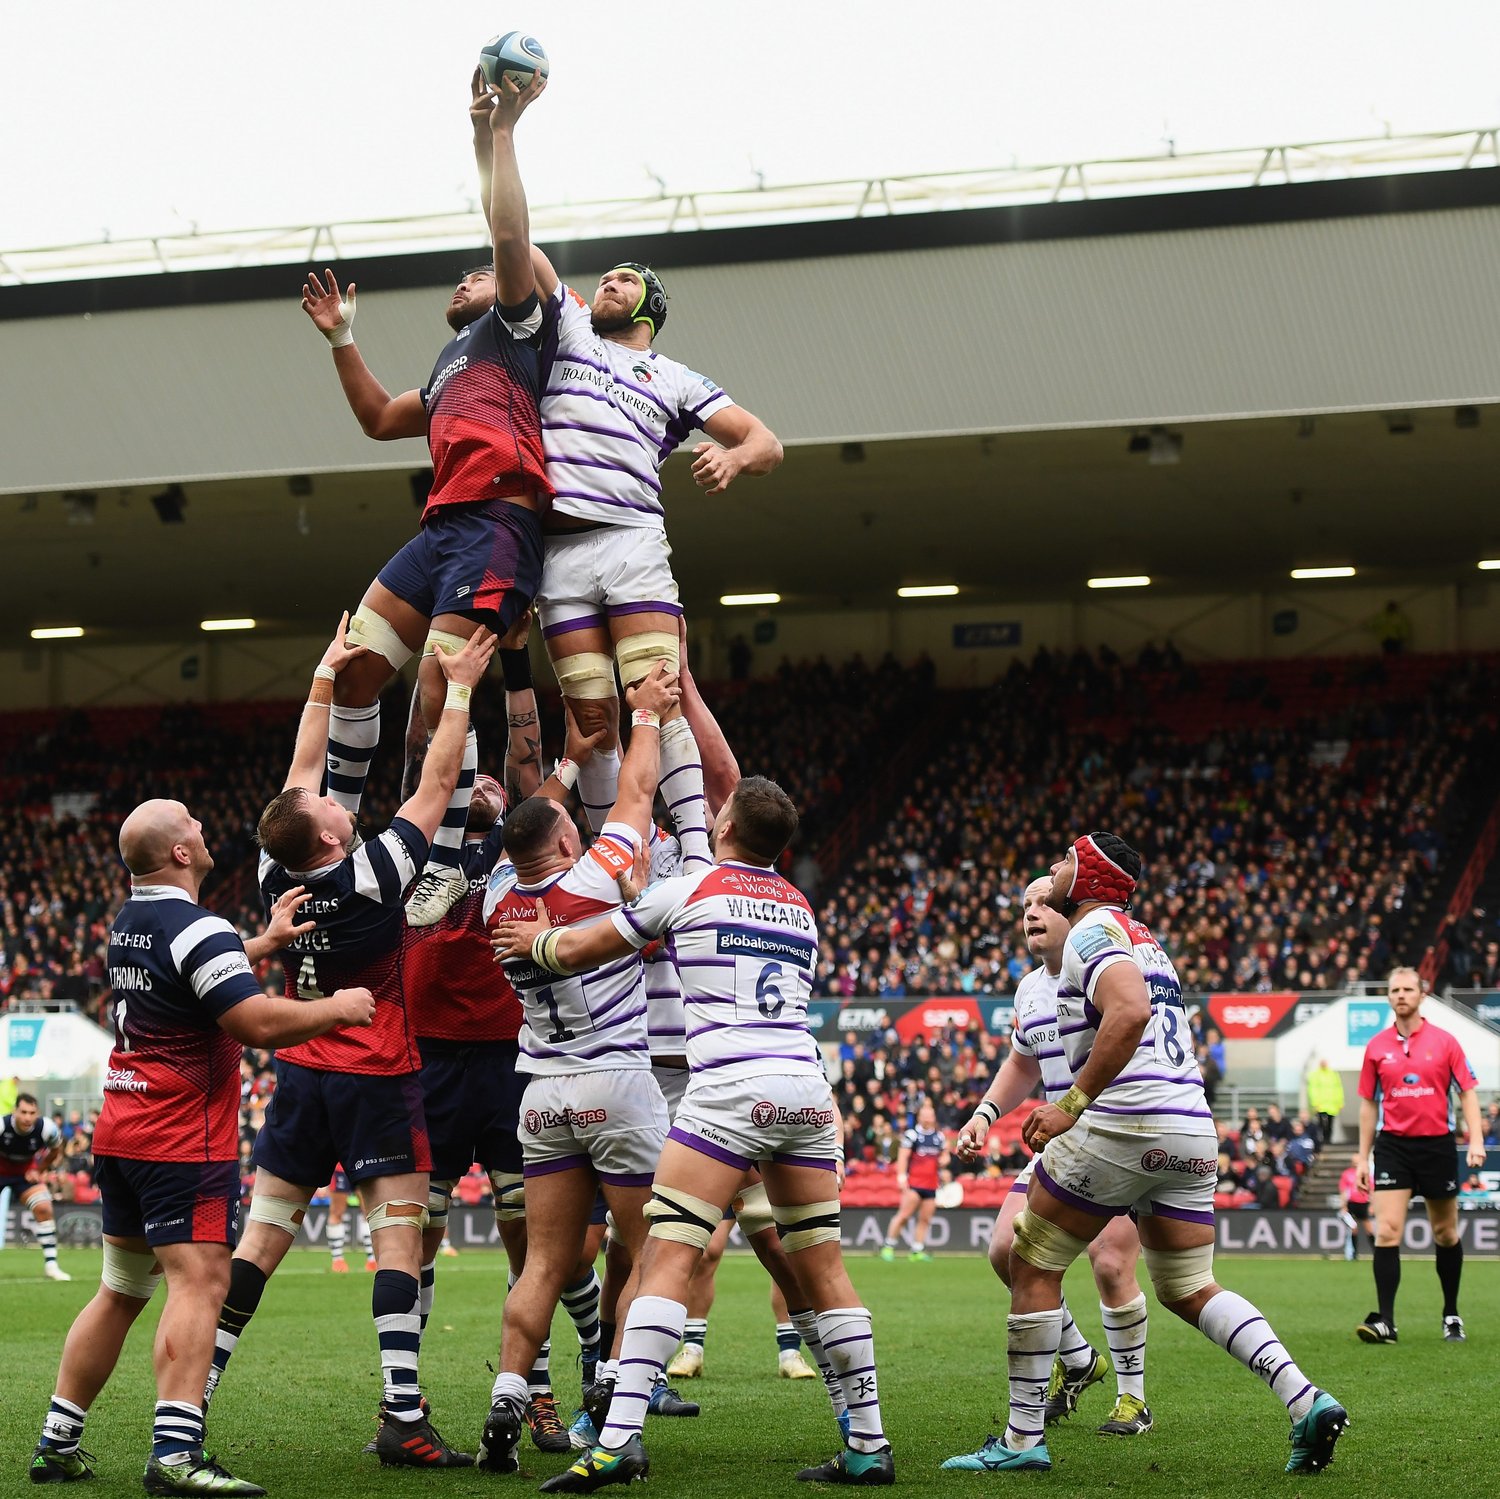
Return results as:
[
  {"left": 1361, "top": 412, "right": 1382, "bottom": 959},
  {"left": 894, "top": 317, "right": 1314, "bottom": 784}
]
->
[{"left": 956, "top": 876, "right": 1152, "bottom": 1436}]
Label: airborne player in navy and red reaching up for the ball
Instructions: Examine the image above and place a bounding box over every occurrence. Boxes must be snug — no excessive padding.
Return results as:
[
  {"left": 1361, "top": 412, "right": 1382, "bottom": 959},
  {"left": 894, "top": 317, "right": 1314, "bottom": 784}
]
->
[{"left": 302, "top": 75, "right": 552, "bottom": 926}]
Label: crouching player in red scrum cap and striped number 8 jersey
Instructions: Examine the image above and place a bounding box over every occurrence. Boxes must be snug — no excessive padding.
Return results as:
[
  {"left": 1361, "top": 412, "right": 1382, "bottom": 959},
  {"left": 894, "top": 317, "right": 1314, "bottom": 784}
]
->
[{"left": 944, "top": 833, "right": 1349, "bottom": 1473}]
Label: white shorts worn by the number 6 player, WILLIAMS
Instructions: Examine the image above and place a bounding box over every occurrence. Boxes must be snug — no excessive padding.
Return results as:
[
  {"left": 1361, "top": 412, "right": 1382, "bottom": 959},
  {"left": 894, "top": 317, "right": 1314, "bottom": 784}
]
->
[{"left": 671, "top": 1073, "right": 843, "bottom": 1170}]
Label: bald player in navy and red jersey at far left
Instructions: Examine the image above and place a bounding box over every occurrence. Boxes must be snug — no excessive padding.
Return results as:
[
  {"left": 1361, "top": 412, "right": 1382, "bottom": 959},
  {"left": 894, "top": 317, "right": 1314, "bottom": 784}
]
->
[{"left": 32, "top": 801, "right": 375, "bottom": 1494}]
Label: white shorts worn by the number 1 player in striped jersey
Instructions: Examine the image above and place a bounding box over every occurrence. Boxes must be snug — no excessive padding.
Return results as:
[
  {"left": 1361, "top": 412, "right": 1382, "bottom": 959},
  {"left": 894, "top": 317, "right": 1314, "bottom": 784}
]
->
[{"left": 521, "top": 1068, "right": 668, "bottom": 1187}]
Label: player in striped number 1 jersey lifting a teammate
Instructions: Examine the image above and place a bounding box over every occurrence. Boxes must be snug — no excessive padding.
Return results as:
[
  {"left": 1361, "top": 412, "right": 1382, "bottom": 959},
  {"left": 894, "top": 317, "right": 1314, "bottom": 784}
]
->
[{"left": 479, "top": 662, "right": 678, "bottom": 1473}]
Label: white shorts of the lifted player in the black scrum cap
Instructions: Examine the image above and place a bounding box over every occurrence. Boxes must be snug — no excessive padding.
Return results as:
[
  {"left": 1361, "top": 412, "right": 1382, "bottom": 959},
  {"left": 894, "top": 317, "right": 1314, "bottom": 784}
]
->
[{"left": 537, "top": 525, "right": 683, "bottom": 636}]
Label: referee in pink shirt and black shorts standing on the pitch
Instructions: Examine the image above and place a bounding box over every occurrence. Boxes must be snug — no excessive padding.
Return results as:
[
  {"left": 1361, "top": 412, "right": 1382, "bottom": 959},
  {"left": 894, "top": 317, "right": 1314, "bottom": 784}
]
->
[{"left": 1355, "top": 968, "right": 1485, "bottom": 1343}]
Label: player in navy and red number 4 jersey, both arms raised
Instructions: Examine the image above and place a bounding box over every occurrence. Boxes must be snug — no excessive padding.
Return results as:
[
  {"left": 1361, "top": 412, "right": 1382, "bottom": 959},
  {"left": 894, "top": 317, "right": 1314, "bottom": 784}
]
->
[{"left": 207, "top": 617, "right": 495, "bottom": 1467}]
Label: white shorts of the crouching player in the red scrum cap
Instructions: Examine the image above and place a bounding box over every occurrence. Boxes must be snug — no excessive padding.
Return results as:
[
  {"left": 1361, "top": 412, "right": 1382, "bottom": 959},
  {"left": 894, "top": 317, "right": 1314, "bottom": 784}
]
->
[{"left": 1032, "top": 1113, "right": 1218, "bottom": 1223}]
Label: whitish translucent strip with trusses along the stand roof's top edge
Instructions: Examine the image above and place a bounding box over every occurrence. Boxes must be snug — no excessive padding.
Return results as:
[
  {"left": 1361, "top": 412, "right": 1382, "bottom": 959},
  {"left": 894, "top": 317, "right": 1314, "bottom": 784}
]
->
[{"left": 0, "top": 126, "right": 1500, "bottom": 287}]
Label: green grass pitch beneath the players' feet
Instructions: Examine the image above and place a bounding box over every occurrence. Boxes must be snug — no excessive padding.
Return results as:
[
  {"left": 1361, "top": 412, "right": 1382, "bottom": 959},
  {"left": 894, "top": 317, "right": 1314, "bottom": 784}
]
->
[{"left": 0, "top": 1248, "right": 1500, "bottom": 1499}]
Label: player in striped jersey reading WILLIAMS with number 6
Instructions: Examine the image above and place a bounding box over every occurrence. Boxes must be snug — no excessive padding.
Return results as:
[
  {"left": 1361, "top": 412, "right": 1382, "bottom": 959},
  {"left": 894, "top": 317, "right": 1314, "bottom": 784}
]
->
[{"left": 497, "top": 776, "right": 896, "bottom": 1493}]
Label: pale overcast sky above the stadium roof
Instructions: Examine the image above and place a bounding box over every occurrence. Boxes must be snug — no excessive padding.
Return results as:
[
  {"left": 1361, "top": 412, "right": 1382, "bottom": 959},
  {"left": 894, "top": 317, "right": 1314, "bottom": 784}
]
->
[{"left": 0, "top": 0, "right": 1500, "bottom": 251}]
